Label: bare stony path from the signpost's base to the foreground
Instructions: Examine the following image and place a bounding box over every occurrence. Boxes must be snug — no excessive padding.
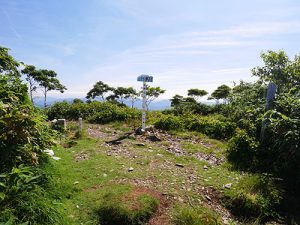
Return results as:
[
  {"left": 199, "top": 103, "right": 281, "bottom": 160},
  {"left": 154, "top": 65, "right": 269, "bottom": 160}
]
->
[{"left": 85, "top": 125, "right": 238, "bottom": 225}]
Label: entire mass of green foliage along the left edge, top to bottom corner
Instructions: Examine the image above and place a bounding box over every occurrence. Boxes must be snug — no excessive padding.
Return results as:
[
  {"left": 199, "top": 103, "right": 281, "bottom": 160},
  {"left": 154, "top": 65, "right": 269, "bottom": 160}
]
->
[{"left": 0, "top": 47, "right": 59, "bottom": 224}]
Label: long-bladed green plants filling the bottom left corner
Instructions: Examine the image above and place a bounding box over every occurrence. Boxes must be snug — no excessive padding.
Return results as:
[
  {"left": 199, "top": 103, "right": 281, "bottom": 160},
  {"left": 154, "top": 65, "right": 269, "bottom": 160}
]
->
[{"left": 0, "top": 165, "right": 61, "bottom": 225}]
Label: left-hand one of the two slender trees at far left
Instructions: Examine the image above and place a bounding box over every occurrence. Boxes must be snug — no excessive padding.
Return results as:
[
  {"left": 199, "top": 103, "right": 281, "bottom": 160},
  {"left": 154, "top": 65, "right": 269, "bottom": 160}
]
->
[{"left": 21, "top": 65, "right": 41, "bottom": 103}]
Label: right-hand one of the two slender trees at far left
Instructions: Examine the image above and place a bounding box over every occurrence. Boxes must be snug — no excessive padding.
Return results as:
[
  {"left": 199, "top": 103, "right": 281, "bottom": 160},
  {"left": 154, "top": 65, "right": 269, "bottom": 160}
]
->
[{"left": 38, "top": 70, "right": 67, "bottom": 108}]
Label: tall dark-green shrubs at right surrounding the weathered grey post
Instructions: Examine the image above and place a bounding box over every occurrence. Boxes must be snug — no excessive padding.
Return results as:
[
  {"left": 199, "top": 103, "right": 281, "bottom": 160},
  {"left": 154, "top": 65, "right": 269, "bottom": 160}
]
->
[{"left": 228, "top": 51, "right": 300, "bottom": 221}]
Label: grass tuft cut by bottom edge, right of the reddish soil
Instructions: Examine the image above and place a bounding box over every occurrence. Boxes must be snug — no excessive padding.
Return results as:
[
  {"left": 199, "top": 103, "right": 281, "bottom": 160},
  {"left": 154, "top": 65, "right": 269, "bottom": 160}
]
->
[{"left": 173, "top": 207, "right": 222, "bottom": 225}]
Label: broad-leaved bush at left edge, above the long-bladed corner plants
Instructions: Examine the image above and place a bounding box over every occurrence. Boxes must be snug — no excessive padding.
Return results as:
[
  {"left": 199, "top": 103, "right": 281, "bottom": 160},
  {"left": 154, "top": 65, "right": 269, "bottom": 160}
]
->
[{"left": 0, "top": 74, "right": 53, "bottom": 172}]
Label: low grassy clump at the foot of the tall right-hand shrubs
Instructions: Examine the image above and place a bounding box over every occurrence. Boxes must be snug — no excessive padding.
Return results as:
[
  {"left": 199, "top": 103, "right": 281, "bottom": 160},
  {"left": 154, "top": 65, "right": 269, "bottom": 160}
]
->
[{"left": 222, "top": 174, "right": 283, "bottom": 222}]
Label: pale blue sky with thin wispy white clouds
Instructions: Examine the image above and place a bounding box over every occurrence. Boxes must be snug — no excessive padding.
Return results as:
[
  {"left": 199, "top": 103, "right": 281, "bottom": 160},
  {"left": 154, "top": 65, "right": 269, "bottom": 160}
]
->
[{"left": 0, "top": 0, "right": 300, "bottom": 98}]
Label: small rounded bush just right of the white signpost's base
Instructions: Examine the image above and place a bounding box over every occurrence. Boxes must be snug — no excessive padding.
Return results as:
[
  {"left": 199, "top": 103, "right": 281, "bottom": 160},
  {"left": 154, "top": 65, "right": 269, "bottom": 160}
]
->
[{"left": 154, "top": 115, "right": 184, "bottom": 131}]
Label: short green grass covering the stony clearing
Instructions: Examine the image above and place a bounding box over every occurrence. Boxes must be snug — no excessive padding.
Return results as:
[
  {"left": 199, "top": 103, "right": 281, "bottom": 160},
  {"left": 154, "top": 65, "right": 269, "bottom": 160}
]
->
[{"left": 48, "top": 125, "right": 284, "bottom": 225}]
